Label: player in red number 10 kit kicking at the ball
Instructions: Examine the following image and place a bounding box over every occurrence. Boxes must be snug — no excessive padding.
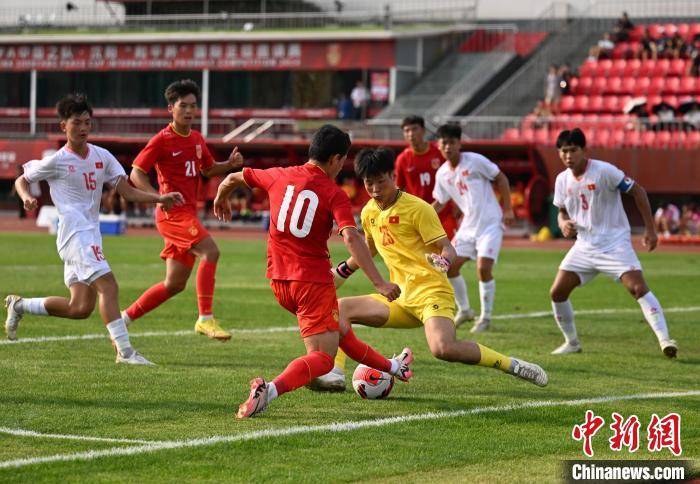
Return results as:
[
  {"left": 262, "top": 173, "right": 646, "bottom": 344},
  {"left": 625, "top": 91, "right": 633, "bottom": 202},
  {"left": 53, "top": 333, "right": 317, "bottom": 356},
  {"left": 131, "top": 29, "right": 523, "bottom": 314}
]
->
[{"left": 214, "top": 125, "right": 413, "bottom": 418}]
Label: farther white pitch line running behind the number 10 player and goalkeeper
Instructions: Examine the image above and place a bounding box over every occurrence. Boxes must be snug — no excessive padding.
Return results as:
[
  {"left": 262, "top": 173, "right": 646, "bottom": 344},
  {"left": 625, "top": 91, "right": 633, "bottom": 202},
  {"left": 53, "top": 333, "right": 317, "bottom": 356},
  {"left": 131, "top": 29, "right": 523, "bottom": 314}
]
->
[{"left": 0, "top": 306, "right": 700, "bottom": 346}]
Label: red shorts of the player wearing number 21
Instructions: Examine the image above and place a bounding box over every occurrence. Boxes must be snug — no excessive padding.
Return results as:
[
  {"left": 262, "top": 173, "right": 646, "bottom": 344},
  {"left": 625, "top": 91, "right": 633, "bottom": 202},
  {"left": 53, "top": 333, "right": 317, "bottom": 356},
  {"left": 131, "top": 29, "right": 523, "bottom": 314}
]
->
[{"left": 156, "top": 211, "right": 209, "bottom": 268}]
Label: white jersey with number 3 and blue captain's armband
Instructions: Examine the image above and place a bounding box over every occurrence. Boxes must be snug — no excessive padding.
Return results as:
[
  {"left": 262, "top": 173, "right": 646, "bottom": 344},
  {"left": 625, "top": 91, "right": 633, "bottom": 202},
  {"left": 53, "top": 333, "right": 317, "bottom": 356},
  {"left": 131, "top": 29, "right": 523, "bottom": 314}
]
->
[{"left": 554, "top": 159, "right": 634, "bottom": 251}]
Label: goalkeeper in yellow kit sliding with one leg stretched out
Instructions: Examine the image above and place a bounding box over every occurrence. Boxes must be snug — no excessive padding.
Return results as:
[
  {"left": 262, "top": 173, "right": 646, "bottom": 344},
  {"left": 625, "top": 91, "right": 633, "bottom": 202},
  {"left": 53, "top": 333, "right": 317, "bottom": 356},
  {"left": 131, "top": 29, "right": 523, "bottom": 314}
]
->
[{"left": 309, "top": 148, "right": 547, "bottom": 391}]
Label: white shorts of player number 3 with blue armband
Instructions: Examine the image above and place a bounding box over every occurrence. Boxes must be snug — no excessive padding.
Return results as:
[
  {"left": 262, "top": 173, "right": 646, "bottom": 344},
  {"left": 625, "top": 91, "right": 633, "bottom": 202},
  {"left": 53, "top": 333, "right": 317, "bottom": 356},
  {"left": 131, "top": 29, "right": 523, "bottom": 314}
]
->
[{"left": 559, "top": 240, "right": 642, "bottom": 286}]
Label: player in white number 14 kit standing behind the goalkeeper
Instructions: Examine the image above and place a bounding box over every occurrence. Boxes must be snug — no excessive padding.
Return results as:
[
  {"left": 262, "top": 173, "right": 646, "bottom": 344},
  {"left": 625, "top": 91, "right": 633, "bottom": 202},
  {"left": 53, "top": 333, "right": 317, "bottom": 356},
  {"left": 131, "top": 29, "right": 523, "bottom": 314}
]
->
[{"left": 433, "top": 124, "right": 515, "bottom": 333}]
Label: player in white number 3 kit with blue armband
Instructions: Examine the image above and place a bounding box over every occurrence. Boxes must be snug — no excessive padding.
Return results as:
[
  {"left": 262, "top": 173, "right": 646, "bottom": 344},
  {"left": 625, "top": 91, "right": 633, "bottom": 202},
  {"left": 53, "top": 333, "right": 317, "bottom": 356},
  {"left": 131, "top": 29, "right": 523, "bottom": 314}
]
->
[{"left": 550, "top": 128, "right": 678, "bottom": 358}]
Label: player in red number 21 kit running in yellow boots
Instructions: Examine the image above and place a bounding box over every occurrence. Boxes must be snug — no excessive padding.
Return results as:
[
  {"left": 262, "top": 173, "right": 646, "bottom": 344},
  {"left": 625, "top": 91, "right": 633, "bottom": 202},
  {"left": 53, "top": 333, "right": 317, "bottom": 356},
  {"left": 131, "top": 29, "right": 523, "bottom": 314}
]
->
[{"left": 122, "top": 79, "right": 243, "bottom": 341}]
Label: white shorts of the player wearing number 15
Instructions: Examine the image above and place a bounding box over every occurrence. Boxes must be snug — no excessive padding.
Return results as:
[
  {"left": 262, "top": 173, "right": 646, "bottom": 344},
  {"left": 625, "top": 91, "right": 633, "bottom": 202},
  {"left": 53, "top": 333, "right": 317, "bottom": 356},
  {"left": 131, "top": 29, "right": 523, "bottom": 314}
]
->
[{"left": 58, "top": 231, "right": 112, "bottom": 288}]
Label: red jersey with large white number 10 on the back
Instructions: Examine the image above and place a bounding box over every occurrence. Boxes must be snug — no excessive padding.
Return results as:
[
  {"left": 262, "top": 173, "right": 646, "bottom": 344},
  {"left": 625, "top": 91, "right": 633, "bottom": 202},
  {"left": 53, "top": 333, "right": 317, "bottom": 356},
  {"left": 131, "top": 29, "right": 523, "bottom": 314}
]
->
[{"left": 243, "top": 163, "right": 356, "bottom": 283}]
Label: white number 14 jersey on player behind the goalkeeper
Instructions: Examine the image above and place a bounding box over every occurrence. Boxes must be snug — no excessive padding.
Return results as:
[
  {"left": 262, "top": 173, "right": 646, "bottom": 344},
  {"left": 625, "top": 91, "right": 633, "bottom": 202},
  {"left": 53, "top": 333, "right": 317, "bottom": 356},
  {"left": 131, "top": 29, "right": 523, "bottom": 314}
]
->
[{"left": 433, "top": 152, "right": 503, "bottom": 237}]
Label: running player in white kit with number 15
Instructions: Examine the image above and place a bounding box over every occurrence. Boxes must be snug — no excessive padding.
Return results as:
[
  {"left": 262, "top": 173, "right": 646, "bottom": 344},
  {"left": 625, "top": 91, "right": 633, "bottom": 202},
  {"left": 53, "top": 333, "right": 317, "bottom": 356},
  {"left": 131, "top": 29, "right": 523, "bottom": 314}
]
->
[{"left": 5, "top": 94, "right": 183, "bottom": 365}]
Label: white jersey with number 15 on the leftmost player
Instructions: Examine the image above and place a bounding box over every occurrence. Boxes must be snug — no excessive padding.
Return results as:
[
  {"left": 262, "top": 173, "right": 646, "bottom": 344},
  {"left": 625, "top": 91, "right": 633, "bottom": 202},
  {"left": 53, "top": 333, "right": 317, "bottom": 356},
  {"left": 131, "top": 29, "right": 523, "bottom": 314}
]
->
[{"left": 23, "top": 144, "right": 126, "bottom": 251}]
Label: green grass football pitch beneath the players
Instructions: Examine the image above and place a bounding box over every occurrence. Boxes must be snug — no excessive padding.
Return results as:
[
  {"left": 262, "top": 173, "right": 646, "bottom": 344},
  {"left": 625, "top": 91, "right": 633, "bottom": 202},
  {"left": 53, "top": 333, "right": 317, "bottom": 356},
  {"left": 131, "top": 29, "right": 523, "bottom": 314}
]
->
[{"left": 0, "top": 233, "right": 700, "bottom": 482}]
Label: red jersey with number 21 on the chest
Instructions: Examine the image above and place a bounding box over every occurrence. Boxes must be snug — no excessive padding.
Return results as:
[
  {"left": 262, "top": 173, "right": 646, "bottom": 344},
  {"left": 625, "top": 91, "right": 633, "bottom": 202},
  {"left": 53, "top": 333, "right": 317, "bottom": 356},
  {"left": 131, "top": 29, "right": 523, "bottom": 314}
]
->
[{"left": 133, "top": 125, "right": 214, "bottom": 213}]
